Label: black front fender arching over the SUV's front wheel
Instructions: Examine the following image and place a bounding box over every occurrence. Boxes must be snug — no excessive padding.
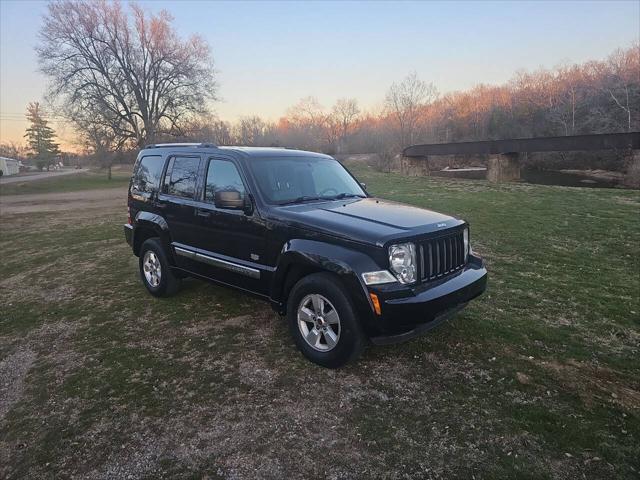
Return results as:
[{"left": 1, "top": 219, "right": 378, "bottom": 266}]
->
[{"left": 270, "top": 239, "right": 380, "bottom": 330}]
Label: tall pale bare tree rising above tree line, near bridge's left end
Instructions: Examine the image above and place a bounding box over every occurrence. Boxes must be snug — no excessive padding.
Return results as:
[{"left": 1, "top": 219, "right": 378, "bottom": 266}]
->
[{"left": 385, "top": 72, "right": 438, "bottom": 146}]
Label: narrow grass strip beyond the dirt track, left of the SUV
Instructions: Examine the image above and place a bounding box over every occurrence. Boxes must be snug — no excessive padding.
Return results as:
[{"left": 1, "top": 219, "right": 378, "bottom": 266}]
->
[{"left": 0, "top": 170, "right": 131, "bottom": 195}]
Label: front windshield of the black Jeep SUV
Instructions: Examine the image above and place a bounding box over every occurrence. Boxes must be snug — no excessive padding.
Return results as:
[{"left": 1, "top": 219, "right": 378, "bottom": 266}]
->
[{"left": 248, "top": 157, "right": 367, "bottom": 205}]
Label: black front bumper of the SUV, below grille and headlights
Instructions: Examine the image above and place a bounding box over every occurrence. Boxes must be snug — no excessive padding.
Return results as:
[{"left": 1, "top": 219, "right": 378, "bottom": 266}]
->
[{"left": 370, "top": 256, "right": 487, "bottom": 344}]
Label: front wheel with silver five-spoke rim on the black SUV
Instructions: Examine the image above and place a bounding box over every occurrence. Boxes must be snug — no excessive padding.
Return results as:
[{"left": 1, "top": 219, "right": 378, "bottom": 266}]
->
[{"left": 287, "top": 273, "right": 366, "bottom": 368}]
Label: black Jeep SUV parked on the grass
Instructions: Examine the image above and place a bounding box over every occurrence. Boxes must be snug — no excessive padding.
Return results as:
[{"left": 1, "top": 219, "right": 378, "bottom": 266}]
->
[{"left": 124, "top": 144, "right": 487, "bottom": 368}]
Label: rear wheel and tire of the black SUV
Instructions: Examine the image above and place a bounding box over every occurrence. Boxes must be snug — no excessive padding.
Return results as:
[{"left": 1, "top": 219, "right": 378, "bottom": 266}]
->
[{"left": 138, "top": 237, "right": 180, "bottom": 297}]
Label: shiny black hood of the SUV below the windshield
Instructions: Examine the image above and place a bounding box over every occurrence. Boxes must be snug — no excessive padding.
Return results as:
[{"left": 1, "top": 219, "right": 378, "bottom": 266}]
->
[{"left": 278, "top": 198, "right": 464, "bottom": 246}]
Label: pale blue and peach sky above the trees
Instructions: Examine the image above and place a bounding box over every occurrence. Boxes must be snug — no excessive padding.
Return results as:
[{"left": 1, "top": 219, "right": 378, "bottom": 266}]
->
[{"left": 0, "top": 0, "right": 640, "bottom": 147}]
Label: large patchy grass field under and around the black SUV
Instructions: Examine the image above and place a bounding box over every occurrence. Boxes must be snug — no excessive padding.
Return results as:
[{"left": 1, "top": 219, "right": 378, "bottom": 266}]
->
[{"left": 0, "top": 166, "right": 640, "bottom": 479}]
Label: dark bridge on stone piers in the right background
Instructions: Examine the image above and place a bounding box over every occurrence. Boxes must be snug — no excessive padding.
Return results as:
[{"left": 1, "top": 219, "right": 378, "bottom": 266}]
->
[{"left": 402, "top": 132, "right": 640, "bottom": 182}]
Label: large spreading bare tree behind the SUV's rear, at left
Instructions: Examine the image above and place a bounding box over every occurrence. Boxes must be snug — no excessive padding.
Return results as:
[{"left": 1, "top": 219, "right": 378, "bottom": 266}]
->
[{"left": 37, "top": 0, "right": 216, "bottom": 146}]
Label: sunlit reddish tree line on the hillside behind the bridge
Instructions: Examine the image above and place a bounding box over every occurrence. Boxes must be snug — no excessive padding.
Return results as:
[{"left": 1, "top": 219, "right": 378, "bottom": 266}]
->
[{"left": 193, "top": 45, "right": 640, "bottom": 158}]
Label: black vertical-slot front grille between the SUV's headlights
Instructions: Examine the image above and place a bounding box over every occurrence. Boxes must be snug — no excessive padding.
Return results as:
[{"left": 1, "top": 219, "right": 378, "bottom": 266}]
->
[{"left": 420, "top": 230, "right": 465, "bottom": 282}]
